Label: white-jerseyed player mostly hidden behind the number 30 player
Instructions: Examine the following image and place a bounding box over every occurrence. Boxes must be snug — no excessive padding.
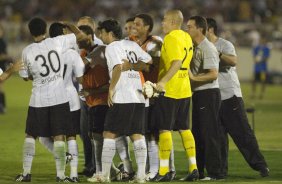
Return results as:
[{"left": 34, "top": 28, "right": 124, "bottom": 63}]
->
[{"left": 39, "top": 22, "right": 84, "bottom": 182}]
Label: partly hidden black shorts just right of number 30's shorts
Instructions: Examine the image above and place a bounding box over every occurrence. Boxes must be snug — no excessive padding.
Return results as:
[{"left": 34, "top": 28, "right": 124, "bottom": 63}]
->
[{"left": 66, "top": 109, "right": 80, "bottom": 136}]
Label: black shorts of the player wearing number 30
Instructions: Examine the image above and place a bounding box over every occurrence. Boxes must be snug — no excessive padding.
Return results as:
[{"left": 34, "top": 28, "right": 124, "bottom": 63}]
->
[{"left": 25, "top": 103, "right": 71, "bottom": 137}]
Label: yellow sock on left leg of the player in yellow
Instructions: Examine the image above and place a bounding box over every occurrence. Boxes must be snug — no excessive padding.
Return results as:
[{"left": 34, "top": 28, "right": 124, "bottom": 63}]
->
[{"left": 159, "top": 132, "right": 172, "bottom": 176}]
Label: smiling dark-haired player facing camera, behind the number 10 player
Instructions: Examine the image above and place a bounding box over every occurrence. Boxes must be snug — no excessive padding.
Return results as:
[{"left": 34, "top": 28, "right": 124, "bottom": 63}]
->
[{"left": 130, "top": 14, "right": 163, "bottom": 181}]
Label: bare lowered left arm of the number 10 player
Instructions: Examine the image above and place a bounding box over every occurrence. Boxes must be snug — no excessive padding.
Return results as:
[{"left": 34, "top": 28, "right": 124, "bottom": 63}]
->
[{"left": 108, "top": 64, "right": 122, "bottom": 106}]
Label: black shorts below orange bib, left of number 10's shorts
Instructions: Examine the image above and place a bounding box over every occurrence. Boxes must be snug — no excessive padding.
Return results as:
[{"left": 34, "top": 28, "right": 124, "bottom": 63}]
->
[{"left": 88, "top": 105, "right": 109, "bottom": 134}]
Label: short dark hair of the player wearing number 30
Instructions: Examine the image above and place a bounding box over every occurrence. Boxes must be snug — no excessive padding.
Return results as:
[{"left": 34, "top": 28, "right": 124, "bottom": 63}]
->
[{"left": 28, "top": 17, "right": 47, "bottom": 36}]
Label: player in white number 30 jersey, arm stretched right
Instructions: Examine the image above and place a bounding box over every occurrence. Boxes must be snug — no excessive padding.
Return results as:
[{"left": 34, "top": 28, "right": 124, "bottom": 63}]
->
[{"left": 15, "top": 17, "right": 89, "bottom": 182}]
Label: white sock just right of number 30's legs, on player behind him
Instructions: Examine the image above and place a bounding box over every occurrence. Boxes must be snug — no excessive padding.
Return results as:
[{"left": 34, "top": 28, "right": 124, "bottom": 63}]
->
[{"left": 68, "top": 140, "right": 78, "bottom": 178}]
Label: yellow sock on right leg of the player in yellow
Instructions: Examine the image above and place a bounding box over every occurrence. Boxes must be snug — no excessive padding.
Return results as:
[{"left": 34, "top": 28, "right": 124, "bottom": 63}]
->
[{"left": 180, "top": 130, "right": 197, "bottom": 173}]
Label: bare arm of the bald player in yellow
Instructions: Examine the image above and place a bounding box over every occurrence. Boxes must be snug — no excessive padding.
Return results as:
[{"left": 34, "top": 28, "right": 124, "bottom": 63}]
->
[{"left": 156, "top": 60, "right": 182, "bottom": 91}]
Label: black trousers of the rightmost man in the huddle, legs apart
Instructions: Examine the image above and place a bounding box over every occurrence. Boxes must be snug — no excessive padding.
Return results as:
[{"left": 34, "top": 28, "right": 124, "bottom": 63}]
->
[{"left": 219, "top": 96, "right": 267, "bottom": 175}]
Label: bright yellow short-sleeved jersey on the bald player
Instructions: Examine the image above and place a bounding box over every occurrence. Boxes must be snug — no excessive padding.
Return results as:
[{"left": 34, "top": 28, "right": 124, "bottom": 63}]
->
[{"left": 158, "top": 30, "right": 193, "bottom": 99}]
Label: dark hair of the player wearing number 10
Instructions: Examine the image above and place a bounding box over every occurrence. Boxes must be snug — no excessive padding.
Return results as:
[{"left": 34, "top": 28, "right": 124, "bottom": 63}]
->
[{"left": 98, "top": 19, "right": 122, "bottom": 39}]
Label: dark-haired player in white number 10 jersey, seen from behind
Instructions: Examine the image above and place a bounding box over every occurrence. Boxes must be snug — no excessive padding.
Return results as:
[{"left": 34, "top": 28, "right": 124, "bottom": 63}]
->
[{"left": 88, "top": 19, "right": 151, "bottom": 182}]
